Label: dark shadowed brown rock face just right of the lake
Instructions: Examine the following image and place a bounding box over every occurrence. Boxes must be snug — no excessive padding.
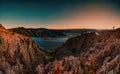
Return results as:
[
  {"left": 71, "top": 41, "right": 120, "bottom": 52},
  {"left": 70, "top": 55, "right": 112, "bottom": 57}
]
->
[{"left": 55, "top": 33, "right": 99, "bottom": 59}]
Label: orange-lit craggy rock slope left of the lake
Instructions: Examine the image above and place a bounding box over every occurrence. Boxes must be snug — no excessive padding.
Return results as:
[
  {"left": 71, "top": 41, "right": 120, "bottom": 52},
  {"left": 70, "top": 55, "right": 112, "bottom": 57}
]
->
[{"left": 0, "top": 25, "right": 46, "bottom": 74}]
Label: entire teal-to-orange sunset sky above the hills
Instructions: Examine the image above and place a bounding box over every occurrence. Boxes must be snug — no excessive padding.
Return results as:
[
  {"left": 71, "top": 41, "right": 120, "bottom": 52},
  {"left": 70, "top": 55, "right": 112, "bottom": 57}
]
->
[{"left": 0, "top": 0, "right": 120, "bottom": 29}]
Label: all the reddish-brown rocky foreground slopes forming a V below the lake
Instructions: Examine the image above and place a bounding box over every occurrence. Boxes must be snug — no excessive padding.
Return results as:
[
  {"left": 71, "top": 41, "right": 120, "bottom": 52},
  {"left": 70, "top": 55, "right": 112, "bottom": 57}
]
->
[{"left": 0, "top": 25, "right": 120, "bottom": 74}]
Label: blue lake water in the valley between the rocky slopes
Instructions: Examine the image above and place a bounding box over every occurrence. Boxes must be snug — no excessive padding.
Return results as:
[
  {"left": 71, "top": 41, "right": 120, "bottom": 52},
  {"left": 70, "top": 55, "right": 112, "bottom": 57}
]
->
[{"left": 31, "top": 37, "right": 69, "bottom": 50}]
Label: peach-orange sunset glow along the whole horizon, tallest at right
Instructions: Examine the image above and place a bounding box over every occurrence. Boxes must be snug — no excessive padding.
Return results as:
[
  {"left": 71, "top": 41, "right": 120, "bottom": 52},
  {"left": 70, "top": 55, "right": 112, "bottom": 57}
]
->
[{"left": 0, "top": 4, "right": 120, "bottom": 29}]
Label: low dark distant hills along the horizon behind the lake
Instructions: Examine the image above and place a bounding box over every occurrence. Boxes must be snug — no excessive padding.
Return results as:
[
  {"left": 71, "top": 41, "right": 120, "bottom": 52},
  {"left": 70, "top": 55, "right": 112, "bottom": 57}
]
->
[{"left": 9, "top": 27, "right": 109, "bottom": 38}]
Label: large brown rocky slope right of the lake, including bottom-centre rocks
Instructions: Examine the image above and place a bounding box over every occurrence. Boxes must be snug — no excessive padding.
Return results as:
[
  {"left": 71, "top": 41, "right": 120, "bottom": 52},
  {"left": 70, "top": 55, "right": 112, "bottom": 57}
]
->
[{"left": 36, "top": 29, "right": 120, "bottom": 74}]
